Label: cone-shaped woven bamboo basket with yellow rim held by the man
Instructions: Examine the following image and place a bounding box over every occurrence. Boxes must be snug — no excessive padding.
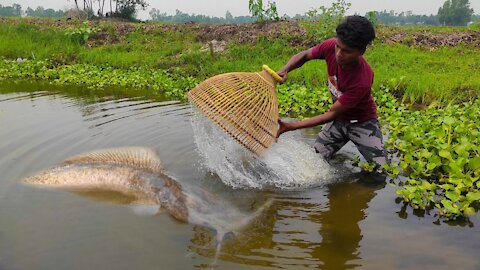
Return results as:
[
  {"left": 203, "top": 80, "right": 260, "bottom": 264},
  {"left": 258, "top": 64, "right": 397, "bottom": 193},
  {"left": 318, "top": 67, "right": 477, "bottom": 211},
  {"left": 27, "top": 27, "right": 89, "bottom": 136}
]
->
[{"left": 188, "top": 65, "right": 282, "bottom": 155}]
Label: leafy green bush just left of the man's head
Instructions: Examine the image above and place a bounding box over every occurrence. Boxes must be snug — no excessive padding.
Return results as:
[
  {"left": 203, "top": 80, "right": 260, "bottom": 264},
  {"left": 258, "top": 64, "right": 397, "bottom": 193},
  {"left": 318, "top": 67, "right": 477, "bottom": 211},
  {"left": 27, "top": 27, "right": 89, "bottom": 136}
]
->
[{"left": 302, "top": 0, "right": 351, "bottom": 41}]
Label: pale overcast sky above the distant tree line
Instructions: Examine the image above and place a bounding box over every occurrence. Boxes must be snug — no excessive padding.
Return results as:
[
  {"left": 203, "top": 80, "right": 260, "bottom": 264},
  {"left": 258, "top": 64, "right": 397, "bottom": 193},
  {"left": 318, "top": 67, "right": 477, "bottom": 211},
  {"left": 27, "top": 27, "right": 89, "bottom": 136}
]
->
[{"left": 0, "top": 0, "right": 480, "bottom": 19}]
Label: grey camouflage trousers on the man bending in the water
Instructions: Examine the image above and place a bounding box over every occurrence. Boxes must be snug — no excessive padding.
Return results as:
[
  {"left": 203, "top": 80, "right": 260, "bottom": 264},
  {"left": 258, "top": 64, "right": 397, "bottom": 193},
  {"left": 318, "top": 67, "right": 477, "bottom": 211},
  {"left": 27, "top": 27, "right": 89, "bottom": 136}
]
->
[{"left": 314, "top": 119, "right": 388, "bottom": 165}]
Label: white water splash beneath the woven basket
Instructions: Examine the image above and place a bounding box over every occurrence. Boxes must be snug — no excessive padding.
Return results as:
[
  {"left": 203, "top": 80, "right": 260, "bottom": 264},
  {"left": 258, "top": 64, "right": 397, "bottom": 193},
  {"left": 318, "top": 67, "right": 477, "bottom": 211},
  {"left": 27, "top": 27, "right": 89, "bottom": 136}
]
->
[{"left": 192, "top": 113, "right": 338, "bottom": 189}]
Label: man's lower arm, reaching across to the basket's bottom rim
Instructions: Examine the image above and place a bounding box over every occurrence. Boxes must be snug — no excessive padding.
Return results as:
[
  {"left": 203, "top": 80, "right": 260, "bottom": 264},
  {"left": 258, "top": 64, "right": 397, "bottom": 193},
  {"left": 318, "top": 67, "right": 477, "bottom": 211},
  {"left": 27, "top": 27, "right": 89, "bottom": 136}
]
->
[{"left": 277, "top": 101, "right": 348, "bottom": 138}]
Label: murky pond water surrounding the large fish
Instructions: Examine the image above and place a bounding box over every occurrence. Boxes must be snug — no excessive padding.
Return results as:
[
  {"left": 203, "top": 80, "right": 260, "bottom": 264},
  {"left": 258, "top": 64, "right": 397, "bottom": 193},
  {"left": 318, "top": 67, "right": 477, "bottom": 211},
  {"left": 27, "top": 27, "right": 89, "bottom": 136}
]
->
[{"left": 0, "top": 82, "right": 480, "bottom": 270}]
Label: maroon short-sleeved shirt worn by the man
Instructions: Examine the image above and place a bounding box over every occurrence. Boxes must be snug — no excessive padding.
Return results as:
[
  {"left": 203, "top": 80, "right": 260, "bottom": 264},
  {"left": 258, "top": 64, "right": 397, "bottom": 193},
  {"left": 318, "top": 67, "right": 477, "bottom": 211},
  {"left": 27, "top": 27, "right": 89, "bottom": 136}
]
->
[{"left": 312, "top": 38, "right": 377, "bottom": 122}]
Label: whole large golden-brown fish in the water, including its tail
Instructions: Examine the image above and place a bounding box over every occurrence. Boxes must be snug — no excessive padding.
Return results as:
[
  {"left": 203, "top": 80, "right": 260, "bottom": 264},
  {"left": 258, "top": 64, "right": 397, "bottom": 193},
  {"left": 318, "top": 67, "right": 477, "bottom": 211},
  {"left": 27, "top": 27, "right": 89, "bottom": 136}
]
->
[{"left": 24, "top": 147, "right": 270, "bottom": 230}]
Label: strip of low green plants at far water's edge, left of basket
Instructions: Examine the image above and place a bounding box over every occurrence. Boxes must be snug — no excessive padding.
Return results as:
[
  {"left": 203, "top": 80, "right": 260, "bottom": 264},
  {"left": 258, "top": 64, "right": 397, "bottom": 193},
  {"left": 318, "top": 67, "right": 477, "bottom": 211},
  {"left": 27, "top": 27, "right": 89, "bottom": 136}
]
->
[{"left": 0, "top": 60, "right": 198, "bottom": 100}]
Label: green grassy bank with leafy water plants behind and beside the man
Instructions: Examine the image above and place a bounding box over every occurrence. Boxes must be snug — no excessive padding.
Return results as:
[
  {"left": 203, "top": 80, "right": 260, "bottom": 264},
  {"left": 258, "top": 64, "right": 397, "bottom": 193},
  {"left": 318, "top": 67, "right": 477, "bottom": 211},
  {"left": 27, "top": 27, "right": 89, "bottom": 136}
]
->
[{"left": 0, "top": 14, "right": 480, "bottom": 218}]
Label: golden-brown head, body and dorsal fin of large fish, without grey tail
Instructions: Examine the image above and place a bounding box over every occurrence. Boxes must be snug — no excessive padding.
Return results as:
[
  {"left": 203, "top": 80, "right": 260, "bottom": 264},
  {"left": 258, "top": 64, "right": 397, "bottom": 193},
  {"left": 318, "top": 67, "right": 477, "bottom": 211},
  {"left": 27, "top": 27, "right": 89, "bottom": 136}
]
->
[{"left": 24, "top": 147, "right": 188, "bottom": 222}]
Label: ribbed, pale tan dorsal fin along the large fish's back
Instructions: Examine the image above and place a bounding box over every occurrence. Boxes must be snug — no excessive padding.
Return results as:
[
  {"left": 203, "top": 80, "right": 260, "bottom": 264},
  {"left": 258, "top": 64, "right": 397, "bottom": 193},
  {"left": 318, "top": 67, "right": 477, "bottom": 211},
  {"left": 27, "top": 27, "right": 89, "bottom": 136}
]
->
[{"left": 63, "top": 147, "right": 163, "bottom": 173}]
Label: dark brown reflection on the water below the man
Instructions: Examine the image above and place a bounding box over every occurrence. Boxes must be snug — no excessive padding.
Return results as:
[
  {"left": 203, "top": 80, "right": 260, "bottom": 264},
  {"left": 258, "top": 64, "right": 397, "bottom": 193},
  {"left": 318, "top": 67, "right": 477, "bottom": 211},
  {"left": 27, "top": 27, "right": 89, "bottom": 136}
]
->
[{"left": 189, "top": 174, "right": 385, "bottom": 270}]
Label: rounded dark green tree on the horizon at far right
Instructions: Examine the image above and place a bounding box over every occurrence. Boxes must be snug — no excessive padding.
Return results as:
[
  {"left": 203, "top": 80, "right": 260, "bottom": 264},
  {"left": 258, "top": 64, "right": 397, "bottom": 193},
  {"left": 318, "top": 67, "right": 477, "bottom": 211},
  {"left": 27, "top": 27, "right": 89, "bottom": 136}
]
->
[{"left": 438, "top": 0, "right": 473, "bottom": 25}]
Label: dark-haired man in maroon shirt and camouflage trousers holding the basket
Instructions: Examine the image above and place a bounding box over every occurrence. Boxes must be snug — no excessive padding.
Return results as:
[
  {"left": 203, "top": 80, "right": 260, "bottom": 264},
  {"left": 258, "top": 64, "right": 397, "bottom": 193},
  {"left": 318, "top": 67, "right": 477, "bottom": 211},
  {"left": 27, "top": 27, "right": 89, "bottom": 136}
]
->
[{"left": 277, "top": 15, "right": 387, "bottom": 169}]
